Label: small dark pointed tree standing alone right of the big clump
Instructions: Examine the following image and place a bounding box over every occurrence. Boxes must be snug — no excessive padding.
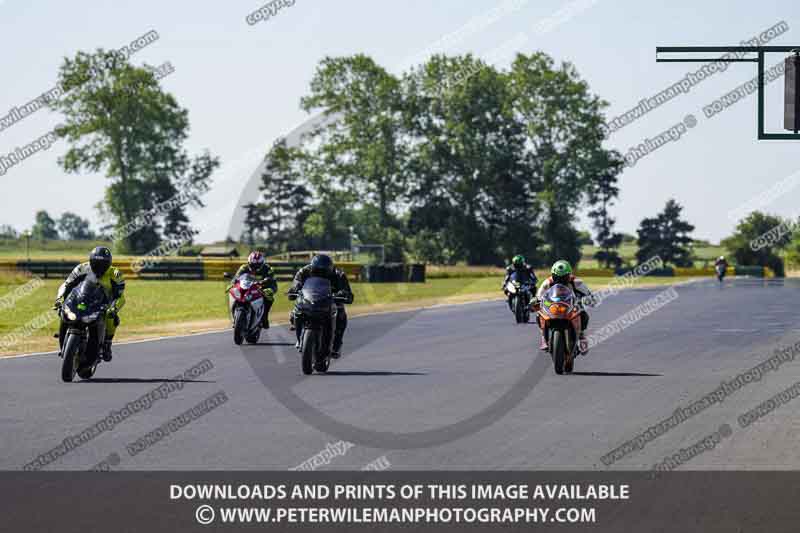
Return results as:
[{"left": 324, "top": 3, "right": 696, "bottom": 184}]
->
[{"left": 636, "top": 199, "right": 694, "bottom": 267}]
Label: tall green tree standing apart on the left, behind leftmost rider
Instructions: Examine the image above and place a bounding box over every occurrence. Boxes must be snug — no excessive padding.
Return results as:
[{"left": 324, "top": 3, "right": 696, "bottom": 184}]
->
[{"left": 49, "top": 49, "right": 219, "bottom": 253}]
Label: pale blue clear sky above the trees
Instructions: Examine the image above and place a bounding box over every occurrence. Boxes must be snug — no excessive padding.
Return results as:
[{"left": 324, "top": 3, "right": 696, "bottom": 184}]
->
[{"left": 0, "top": 0, "right": 800, "bottom": 241}]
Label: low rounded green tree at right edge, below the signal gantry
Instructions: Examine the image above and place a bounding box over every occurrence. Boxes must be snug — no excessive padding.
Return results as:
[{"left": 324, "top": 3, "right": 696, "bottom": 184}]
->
[{"left": 720, "top": 211, "right": 794, "bottom": 276}]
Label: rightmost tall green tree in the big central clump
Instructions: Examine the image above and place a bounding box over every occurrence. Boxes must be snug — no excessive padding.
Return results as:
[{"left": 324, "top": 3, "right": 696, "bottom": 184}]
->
[{"left": 508, "top": 52, "right": 617, "bottom": 264}]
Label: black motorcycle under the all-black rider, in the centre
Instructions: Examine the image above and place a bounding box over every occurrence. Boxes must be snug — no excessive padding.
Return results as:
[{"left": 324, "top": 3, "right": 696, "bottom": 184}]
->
[{"left": 289, "top": 276, "right": 347, "bottom": 375}]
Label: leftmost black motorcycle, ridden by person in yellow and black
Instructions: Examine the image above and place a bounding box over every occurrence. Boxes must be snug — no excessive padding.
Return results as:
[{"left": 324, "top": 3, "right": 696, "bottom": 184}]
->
[{"left": 58, "top": 279, "right": 109, "bottom": 383}]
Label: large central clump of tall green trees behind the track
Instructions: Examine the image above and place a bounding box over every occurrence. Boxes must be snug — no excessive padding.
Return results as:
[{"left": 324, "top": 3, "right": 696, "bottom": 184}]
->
[{"left": 242, "top": 53, "right": 623, "bottom": 266}]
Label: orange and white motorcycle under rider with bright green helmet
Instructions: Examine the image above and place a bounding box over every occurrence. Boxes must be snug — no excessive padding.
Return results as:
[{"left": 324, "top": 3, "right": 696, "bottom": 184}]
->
[{"left": 535, "top": 284, "right": 581, "bottom": 374}]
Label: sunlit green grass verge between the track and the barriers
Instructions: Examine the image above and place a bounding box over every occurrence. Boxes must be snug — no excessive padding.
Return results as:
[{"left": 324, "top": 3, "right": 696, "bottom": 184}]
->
[{"left": 0, "top": 276, "right": 700, "bottom": 355}]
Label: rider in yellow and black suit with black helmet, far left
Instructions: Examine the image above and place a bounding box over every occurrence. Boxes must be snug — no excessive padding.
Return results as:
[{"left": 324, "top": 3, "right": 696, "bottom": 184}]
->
[{"left": 55, "top": 246, "right": 125, "bottom": 361}]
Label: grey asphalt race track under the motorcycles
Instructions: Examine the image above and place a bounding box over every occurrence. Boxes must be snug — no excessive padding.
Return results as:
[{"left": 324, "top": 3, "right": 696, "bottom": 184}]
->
[{"left": 0, "top": 279, "right": 800, "bottom": 470}]
